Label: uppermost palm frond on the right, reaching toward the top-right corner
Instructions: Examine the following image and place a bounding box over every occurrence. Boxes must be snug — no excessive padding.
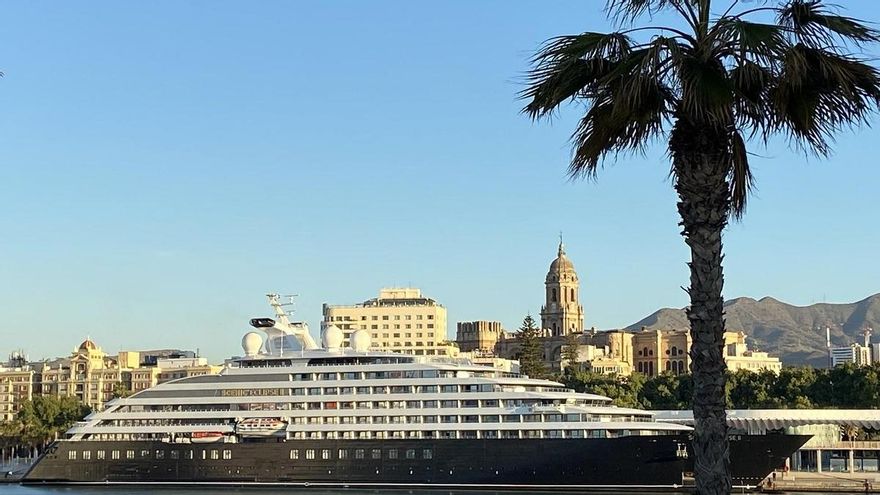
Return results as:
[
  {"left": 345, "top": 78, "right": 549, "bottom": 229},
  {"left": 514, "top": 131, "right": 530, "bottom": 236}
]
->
[{"left": 778, "top": 0, "right": 880, "bottom": 48}]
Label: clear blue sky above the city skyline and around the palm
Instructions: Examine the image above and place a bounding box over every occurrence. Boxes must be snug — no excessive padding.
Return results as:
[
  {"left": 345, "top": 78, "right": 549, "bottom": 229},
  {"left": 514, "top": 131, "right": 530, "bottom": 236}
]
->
[{"left": 0, "top": 0, "right": 880, "bottom": 360}]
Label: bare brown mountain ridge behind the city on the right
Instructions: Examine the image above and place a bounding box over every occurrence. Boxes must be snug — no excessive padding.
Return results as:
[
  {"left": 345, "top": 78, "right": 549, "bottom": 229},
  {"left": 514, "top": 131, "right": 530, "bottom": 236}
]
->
[{"left": 626, "top": 294, "right": 880, "bottom": 366}]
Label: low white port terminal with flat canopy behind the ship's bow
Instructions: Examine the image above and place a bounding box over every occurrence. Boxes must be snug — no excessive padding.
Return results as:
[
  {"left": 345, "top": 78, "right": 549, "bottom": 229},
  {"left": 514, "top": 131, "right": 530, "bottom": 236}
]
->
[{"left": 655, "top": 409, "right": 880, "bottom": 475}]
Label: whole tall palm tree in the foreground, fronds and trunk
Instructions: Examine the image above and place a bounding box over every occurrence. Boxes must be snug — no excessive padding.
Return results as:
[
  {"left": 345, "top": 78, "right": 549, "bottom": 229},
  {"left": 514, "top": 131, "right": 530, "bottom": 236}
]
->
[{"left": 521, "top": 0, "right": 880, "bottom": 494}]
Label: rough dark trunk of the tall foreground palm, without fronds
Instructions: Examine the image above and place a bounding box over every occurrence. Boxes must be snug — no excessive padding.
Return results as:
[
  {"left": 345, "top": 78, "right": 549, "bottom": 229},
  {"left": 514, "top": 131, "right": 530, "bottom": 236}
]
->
[{"left": 669, "top": 119, "right": 731, "bottom": 495}]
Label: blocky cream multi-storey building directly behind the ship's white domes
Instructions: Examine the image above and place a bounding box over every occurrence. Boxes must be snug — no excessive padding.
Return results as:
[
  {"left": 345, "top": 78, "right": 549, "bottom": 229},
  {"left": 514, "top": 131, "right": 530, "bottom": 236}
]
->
[{"left": 322, "top": 288, "right": 458, "bottom": 356}]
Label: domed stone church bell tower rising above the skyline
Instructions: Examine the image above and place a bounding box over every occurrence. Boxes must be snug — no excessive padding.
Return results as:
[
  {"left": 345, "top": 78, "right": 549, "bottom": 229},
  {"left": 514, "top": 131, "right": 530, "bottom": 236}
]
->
[{"left": 541, "top": 236, "right": 584, "bottom": 336}]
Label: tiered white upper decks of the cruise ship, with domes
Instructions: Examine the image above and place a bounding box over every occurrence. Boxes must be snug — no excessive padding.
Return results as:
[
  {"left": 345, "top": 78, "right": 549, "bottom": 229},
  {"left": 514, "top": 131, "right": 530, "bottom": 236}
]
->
[{"left": 69, "top": 299, "right": 689, "bottom": 442}]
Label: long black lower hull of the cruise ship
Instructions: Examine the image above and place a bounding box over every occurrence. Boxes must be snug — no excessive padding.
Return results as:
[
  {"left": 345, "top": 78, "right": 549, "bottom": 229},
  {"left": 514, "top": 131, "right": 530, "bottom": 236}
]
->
[{"left": 22, "top": 435, "right": 809, "bottom": 491}]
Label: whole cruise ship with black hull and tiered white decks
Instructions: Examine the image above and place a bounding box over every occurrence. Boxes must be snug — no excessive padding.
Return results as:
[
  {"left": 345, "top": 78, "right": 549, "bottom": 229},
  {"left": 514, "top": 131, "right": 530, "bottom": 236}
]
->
[{"left": 23, "top": 294, "right": 808, "bottom": 491}]
